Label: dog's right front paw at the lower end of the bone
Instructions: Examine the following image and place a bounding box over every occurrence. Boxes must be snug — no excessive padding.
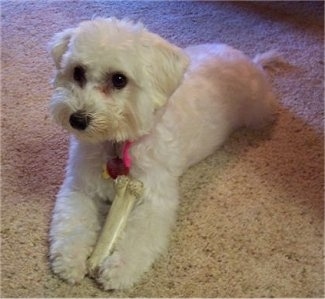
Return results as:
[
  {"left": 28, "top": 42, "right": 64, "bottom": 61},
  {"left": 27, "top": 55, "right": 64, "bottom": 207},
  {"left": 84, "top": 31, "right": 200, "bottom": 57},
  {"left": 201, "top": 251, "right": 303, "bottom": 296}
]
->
[{"left": 95, "top": 252, "right": 141, "bottom": 291}]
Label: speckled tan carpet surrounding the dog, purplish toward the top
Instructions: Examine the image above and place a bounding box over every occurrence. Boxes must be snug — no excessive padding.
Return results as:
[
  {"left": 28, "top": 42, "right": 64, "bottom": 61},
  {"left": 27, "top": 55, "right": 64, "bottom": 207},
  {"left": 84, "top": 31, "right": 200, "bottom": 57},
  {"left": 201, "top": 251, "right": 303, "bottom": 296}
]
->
[{"left": 1, "top": 1, "right": 324, "bottom": 297}]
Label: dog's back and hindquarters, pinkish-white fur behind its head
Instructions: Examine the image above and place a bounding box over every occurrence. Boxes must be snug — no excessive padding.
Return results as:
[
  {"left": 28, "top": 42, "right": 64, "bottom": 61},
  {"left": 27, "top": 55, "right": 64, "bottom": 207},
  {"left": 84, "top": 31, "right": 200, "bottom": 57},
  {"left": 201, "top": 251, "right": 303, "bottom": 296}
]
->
[{"left": 156, "top": 44, "right": 275, "bottom": 168}]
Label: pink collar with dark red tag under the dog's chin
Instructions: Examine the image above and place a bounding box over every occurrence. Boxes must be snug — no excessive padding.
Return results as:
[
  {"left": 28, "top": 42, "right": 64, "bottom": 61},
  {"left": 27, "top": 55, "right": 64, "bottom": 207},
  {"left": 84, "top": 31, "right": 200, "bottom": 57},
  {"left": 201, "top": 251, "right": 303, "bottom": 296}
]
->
[{"left": 104, "top": 140, "right": 132, "bottom": 179}]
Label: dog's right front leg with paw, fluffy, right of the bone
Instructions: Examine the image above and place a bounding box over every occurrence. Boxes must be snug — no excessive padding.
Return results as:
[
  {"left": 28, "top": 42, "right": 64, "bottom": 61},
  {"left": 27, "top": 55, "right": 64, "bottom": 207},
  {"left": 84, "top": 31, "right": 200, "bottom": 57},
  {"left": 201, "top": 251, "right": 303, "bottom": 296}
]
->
[{"left": 97, "top": 176, "right": 178, "bottom": 290}]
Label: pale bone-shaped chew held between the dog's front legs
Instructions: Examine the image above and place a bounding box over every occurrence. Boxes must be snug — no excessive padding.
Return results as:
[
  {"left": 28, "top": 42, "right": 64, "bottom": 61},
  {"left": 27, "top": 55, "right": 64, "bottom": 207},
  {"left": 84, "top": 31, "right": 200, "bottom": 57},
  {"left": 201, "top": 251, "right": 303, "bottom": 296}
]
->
[{"left": 88, "top": 176, "right": 143, "bottom": 276}]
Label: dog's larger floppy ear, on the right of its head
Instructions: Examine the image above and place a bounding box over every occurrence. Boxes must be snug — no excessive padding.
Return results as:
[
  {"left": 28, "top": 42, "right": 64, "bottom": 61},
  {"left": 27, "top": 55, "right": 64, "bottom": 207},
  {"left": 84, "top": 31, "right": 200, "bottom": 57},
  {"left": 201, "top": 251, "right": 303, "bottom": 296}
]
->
[{"left": 143, "top": 33, "right": 189, "bottom": 108}]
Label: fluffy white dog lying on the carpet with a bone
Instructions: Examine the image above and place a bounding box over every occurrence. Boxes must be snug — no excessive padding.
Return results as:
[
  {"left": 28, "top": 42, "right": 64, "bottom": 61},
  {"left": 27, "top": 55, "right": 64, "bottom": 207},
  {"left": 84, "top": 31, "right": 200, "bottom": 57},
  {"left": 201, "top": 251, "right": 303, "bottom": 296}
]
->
[{"left": 50, "top": 18, "right": 276, "bottom": 290}]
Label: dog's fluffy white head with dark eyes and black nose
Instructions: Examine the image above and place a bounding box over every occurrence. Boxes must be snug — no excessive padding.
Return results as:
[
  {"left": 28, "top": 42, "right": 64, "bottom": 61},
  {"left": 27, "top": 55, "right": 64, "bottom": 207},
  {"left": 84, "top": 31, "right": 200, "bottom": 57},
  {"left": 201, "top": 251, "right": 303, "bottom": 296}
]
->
[{"left": 50, "top": 18, "right": 188, "bottom": 142}]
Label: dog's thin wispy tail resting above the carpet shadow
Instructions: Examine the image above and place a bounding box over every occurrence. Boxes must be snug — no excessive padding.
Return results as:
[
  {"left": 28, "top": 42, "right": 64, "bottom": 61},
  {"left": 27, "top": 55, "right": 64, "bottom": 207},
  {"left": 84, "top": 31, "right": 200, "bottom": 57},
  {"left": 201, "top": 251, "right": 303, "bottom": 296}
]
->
[{"left": 253, "top": 50, "right": 288, "bottom": 71}]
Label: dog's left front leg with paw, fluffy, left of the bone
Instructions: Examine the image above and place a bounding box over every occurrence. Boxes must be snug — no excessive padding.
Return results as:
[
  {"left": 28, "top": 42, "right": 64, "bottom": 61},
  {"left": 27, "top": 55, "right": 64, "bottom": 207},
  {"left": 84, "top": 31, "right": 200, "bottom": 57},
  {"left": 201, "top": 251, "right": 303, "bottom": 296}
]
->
[{"left": 50, "top": 185, "right": 104, "bottom": 283}]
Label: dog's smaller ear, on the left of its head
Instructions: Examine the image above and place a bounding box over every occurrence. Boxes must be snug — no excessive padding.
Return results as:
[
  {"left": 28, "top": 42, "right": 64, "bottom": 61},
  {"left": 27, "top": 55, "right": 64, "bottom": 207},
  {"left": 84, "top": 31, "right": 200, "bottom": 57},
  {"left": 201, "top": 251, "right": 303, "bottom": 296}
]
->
[{"left": 49, "top": 28, "right": 75, "bottom": 69}]
